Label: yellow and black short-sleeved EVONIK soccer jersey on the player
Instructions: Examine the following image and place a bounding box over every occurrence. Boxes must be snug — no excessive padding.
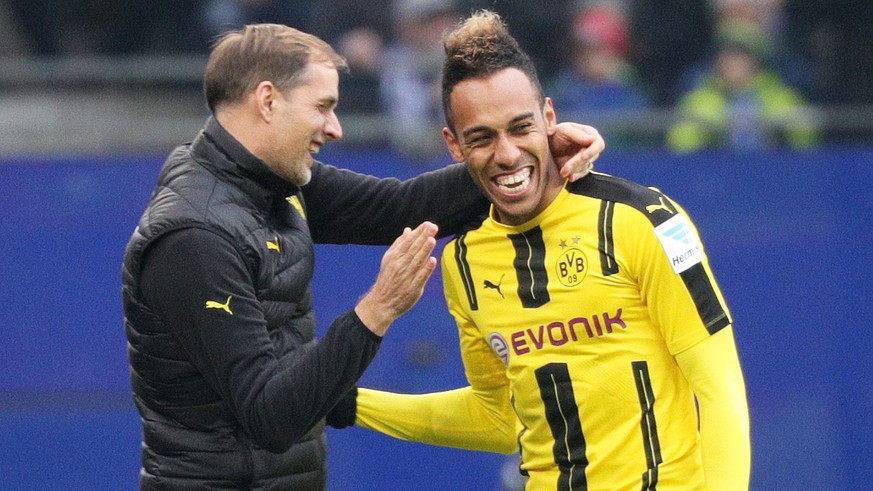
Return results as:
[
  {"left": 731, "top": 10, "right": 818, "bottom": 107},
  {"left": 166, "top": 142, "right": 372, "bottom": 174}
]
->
[{"left": 442, "top": 173, "right": 731, "bottom": 491}]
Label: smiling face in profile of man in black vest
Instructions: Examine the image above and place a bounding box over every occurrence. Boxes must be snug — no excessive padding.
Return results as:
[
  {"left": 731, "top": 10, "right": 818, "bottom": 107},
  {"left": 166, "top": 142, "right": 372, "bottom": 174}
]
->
[{"left": 263, "top": 63, "right": 342, "bottom": 186}]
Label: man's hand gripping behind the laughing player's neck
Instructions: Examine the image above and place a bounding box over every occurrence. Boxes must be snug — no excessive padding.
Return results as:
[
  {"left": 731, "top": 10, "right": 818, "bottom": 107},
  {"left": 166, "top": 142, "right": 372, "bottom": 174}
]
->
[{"left": 549, "top": 123, "right": 606, "bottom": 181}]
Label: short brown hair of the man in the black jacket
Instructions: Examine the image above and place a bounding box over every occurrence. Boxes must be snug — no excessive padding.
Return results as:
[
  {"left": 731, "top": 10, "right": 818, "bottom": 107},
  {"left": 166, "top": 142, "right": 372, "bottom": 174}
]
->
[{"left": 203, "top": 24, "right": 348, "bottom": 114}]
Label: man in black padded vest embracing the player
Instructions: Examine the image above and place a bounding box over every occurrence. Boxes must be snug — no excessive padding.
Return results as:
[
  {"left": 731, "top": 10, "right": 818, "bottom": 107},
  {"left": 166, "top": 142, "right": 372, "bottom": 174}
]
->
[{"left": 122, "top": 24, "right": 603, "bottom": 490}]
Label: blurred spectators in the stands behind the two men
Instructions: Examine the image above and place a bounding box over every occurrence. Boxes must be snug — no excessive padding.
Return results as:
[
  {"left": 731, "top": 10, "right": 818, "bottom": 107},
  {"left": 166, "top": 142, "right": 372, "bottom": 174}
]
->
[{"left": 0, "top": 0, "right": 873, "bottom": 155}]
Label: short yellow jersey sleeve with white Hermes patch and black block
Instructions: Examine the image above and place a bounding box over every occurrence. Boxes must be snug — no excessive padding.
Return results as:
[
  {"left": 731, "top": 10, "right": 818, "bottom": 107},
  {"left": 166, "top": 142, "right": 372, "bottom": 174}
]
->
[{"left": 621, "top": 201, "right": 731, "bottom": 355}]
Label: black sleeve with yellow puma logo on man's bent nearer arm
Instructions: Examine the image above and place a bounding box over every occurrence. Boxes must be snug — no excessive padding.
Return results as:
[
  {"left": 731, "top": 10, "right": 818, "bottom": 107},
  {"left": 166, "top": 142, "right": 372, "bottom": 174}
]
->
[{"left": 141, "top": 229, "right": 381, "bottom": 452}]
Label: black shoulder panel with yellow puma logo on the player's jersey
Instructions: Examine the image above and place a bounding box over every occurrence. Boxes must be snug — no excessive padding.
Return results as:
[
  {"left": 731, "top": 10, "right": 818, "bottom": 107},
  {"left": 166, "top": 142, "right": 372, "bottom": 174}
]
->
[{"left": 567, "top": 172, "right": 681, "bottom": 226}]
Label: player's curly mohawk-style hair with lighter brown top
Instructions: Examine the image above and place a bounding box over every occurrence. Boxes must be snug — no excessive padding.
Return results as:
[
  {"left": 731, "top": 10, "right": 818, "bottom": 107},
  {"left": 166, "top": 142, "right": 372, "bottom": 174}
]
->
[{"left": 442, "top": 10, "right": 544, "bottom": 131}]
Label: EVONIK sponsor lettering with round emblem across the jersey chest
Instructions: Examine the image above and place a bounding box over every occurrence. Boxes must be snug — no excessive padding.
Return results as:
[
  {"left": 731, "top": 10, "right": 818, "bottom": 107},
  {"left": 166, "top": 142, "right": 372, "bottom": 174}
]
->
[{"left": 498, "top": 309, "right": 627, "bottom": 363}]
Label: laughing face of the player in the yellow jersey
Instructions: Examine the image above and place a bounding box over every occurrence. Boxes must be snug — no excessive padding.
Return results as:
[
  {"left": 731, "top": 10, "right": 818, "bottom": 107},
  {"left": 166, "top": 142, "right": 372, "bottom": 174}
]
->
[{"left": 443, "top": 68, "right": 563, "bottom": 225}]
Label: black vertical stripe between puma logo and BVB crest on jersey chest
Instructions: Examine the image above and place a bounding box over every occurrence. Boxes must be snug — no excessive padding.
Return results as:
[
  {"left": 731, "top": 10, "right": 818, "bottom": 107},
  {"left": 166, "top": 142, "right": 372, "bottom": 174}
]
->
[{"left": 507, "top": 227, "right": 550, "bottom": 309}]
